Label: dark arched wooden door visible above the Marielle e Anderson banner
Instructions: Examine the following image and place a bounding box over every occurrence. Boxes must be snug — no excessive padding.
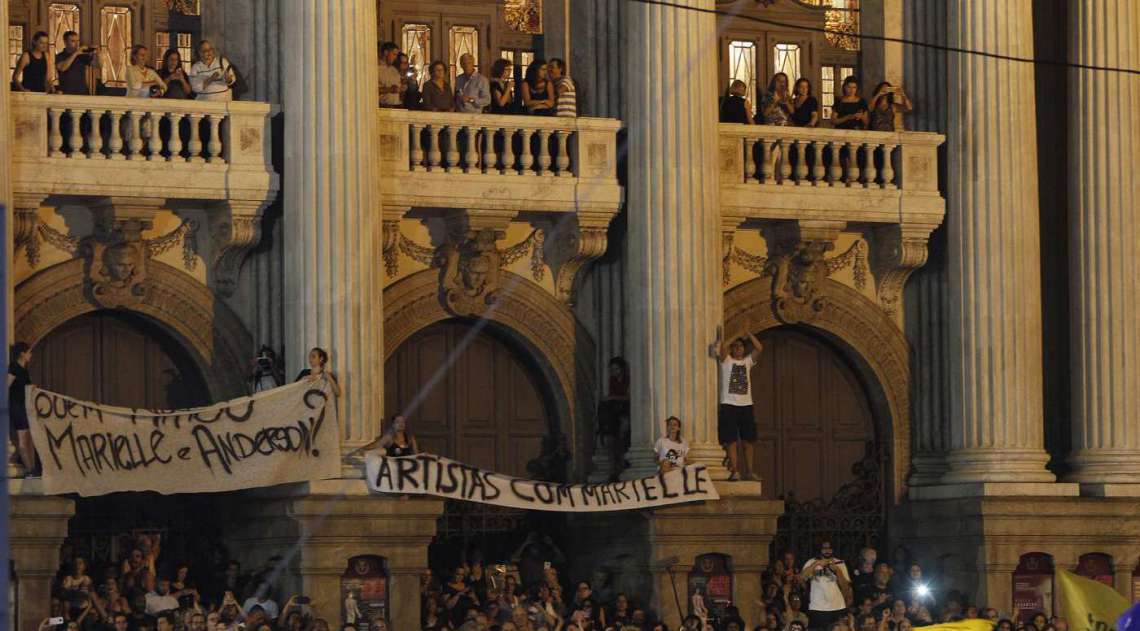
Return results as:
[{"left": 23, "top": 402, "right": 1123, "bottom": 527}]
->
[{"left": 30, "top": 311, "right": 210, "bottom": 408}]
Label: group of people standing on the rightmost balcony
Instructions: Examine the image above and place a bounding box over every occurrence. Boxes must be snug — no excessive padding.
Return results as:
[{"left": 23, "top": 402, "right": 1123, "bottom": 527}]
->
[{"left": 720, "top": 72, "right": 913, "bottom": 131}]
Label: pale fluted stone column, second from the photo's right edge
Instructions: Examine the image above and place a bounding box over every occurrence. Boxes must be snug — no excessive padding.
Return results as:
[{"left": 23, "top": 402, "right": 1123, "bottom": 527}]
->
[{"left": 943, "top": 0, "right": 1053, "bottom": 485}]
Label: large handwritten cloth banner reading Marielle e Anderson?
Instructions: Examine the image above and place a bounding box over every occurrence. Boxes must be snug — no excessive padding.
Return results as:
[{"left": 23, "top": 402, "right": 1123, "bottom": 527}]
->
[{"left": 27, "top": 382, "right": 341, "bottom": 495}]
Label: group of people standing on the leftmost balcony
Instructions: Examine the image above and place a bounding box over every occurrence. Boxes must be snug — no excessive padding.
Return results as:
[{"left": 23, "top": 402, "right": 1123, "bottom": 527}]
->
[{"left": 11, "top": 31, "right": 238, "bottom": 101}]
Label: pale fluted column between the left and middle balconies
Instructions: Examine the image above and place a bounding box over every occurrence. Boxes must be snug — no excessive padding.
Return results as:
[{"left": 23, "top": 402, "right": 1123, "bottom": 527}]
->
[{"left": 279, "top": 0, "right": 384, "bottom": 457}]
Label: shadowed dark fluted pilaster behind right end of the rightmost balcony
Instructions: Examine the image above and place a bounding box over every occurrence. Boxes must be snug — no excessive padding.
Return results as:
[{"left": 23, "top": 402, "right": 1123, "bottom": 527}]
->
[{"left": 902, "top": 0, "right": 950, "bottom": 486}]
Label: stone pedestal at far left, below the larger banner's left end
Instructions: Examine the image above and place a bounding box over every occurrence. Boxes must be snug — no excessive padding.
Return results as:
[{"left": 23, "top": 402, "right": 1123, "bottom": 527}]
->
[{"left": 3, "top": 478, "right": 75, "bottom": 631}]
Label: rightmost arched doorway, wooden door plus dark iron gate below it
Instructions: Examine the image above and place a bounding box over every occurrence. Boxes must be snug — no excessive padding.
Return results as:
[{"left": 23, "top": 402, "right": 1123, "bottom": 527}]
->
[{"left": 752, "top": 327, "right": 886, "bottom": 558}]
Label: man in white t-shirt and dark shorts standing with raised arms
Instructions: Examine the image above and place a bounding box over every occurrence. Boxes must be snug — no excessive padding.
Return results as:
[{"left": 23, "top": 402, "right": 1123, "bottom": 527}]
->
[{"left": 716, "top": 328, "right": 764, "bottom": 481}]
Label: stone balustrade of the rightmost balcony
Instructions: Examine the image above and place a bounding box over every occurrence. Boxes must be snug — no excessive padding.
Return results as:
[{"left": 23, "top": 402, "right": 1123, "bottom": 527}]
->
[{"left": 719, "top": 123, "right": 945, "bottom": 226}]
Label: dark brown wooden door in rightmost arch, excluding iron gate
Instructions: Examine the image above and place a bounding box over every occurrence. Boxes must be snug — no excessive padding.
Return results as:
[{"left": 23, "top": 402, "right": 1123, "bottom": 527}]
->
[{"left": 752, "top": 329, "right": 876, "bottom": 502}]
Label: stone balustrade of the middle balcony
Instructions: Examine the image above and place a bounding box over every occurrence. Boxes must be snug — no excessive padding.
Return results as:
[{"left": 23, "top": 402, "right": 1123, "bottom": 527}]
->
[{"left": 378, "top": 109, "right": 621, "bottom": 213}]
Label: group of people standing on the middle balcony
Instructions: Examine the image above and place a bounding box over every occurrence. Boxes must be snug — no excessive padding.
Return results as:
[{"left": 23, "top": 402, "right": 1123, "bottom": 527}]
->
[{"left": 380, "top": 42, "right": 578, "bottom": 116}]
